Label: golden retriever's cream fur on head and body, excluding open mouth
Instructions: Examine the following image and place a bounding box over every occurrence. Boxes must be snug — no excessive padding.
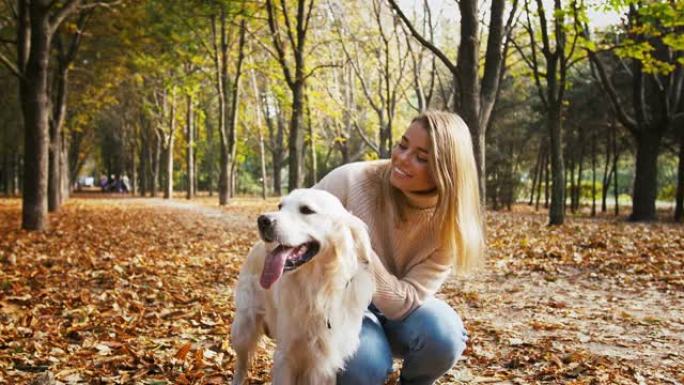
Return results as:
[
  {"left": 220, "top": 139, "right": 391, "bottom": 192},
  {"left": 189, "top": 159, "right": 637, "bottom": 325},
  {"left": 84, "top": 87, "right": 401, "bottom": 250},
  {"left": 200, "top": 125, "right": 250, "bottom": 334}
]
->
[{"left": 231, "top": 189, "right": 373, "bottom": 385}]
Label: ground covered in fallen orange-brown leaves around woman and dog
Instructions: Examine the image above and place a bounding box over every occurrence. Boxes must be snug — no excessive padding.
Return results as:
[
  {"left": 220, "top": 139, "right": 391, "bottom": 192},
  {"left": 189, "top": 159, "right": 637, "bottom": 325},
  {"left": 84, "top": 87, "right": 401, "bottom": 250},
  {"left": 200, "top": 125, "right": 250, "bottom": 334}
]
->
[{"left": 0, "top": 195, "right": 684, "bottom": 384}]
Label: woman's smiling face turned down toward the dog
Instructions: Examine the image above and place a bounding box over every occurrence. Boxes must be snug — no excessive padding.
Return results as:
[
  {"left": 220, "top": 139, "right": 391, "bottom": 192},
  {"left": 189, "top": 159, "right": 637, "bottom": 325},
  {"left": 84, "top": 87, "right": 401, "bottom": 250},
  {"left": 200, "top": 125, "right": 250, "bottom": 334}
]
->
[{"left": 390, "top": 121, "right": 435, "bottom": 193}]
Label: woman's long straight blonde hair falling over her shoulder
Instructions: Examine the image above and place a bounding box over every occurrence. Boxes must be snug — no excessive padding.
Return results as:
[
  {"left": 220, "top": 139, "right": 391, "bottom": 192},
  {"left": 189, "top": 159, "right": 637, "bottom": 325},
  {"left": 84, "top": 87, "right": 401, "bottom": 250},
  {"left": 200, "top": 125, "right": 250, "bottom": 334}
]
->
[{"left": 387, "top": 111, "right": 485, "bottom": 274}]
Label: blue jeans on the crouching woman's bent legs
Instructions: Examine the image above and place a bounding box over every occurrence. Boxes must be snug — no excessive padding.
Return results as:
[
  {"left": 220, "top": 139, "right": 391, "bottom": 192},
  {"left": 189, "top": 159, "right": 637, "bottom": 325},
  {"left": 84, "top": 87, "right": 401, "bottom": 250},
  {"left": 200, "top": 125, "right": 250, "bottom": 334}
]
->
[{"left": 337, "top": 298, "right": 468, "bottom": 385}]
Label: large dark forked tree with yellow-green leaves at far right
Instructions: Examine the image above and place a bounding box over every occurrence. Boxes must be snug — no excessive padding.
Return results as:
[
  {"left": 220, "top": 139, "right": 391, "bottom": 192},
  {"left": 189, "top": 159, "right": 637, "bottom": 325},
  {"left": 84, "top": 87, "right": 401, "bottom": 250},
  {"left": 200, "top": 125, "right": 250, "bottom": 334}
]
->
[{"left": 585, "top": 2, "right": 684, "bottom": 221}]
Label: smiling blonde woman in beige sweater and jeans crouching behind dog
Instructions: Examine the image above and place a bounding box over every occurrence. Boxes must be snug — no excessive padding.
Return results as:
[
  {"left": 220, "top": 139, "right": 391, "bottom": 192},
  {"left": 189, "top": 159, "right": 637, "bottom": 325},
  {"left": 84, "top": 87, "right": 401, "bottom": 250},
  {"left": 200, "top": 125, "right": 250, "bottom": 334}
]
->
[{"left": 316, "top": 111, "right": 484, "bottom": 385}]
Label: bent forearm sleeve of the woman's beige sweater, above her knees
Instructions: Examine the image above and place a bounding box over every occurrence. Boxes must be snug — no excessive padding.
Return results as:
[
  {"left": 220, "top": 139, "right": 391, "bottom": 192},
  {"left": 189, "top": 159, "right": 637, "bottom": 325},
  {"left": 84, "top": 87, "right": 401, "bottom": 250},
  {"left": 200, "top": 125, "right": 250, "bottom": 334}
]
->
[{"left": 371, "top": 250, "right": 451, "bottom": 320}]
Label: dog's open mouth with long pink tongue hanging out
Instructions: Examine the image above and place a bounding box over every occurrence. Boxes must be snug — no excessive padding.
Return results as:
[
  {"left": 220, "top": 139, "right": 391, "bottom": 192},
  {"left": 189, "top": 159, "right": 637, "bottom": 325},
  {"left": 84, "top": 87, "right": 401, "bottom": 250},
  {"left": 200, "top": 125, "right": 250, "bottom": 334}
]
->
[{"left": 259, "top": 241, "right": 320, "bottom": 289}]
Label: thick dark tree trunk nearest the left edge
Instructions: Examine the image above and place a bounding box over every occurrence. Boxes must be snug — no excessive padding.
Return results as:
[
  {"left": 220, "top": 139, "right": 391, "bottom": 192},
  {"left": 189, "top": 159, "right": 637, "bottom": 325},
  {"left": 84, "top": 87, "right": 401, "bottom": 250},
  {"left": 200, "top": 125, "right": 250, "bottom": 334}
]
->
[{"left": 19, "top": 4, "right": 50, "bottom": 230}]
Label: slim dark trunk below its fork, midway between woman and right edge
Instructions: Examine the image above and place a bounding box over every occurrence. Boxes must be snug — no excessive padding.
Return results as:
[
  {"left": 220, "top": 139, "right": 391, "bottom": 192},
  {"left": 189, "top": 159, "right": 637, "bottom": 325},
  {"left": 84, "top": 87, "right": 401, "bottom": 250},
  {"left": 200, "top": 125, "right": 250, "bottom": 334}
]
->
[{"left": 547, "top": 103, "right": 565, "bottom": 225}]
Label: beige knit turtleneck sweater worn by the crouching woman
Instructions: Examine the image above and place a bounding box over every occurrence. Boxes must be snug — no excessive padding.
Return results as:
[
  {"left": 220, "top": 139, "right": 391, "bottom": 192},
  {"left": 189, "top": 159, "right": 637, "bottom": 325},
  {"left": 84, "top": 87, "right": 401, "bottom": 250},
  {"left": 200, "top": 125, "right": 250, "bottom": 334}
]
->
[{"left": 314, "top": 160, "right": 451, "bottom": 319}]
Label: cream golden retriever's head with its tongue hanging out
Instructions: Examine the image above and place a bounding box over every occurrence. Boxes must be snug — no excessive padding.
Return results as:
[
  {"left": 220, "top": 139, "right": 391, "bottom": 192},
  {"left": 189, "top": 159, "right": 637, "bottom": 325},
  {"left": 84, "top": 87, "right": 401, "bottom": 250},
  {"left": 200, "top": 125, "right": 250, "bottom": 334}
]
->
[{"left": 257, "top": 189, "right": 371, "bottom": 289}]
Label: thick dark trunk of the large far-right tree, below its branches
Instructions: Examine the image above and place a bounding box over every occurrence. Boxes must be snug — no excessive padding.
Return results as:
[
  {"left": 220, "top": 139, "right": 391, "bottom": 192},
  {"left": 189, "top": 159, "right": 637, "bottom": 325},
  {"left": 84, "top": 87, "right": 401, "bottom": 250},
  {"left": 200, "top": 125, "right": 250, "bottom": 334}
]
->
[{"left": 629, "top": 129, "right": 662, "bottom": 221}]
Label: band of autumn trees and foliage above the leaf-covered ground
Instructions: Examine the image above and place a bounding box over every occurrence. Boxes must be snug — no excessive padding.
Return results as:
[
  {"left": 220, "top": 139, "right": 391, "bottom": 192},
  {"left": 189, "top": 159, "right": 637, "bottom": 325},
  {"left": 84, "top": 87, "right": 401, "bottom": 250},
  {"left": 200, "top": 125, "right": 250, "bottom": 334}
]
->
[{"left": 0, "top": 0, "right": 684, "bottom": 228}]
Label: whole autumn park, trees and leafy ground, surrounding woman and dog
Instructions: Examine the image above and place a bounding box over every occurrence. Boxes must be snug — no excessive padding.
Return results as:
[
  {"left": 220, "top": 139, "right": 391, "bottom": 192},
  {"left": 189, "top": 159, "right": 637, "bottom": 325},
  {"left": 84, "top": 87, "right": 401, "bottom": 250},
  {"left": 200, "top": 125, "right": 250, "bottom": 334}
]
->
[{"left": 0, "top": 0, "right": 684, "bottom": 385}]
